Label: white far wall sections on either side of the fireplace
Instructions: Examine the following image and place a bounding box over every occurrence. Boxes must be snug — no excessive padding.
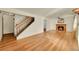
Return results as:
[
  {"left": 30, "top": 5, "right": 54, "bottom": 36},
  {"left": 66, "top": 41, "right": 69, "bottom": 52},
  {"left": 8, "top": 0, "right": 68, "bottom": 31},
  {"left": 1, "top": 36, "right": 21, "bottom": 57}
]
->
[{"left": 47, "top": 15, "right": 74, "bottom": 32}]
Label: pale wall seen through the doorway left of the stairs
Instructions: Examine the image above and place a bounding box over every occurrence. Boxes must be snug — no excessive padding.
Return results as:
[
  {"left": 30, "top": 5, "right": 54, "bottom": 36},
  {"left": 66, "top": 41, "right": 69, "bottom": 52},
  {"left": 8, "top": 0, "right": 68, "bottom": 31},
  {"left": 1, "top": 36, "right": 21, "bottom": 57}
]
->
[{"left": 3, "top": 14, "right": 14, "bottom": 34}]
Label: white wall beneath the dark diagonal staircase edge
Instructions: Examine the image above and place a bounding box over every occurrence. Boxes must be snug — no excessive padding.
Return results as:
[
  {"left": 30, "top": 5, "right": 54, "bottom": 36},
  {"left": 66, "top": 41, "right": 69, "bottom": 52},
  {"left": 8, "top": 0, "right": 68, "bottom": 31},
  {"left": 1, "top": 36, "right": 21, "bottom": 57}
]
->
[{"left": 17, "top": 16, "right": 44, "bottom": 39}]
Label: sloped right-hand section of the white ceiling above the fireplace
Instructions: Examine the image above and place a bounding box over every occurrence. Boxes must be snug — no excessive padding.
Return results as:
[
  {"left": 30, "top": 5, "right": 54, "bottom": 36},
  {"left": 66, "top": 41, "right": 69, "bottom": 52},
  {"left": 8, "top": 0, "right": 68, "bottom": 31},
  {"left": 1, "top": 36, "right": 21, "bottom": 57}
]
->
[{"left": 47, "top": 8, "right": 74, "bottom": 18}]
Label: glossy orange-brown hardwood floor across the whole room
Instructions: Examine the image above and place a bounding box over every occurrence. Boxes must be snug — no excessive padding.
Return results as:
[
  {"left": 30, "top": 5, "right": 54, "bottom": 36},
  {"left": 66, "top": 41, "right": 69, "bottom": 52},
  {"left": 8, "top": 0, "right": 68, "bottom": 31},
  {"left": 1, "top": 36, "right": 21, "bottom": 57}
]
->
[{"left": 0, "top": 31, "right": 78, "bottom": 51}]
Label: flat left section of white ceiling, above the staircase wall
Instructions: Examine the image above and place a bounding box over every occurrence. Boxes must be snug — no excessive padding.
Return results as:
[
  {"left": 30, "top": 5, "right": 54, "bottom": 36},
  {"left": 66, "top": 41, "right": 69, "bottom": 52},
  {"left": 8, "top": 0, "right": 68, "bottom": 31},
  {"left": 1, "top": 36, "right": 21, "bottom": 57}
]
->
[{"left": 16, "top": 8, "right": 57, "bottom": 16}]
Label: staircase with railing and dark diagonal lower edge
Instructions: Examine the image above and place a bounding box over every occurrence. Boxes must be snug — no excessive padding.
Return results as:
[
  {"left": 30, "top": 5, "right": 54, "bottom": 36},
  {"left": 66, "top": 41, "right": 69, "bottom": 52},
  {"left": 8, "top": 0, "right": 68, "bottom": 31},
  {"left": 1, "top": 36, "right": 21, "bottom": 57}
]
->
[{"left": 16, "top": 16, "right": 34, "bottom": 36}]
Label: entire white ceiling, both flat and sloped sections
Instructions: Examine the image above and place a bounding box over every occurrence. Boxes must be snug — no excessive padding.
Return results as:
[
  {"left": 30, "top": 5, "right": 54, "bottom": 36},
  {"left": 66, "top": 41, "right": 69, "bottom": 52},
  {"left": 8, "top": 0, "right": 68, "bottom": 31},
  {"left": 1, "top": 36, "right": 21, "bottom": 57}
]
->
[{"left": 16, "top": 8, "right": 74, "bottom": 18}]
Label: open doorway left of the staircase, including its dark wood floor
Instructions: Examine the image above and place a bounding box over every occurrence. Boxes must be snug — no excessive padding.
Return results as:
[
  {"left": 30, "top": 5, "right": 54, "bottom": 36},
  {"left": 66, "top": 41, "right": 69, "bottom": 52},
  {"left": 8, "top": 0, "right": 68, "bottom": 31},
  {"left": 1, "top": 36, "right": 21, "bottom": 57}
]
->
[{"left": 2, "top": 14, "right": 16, "bottom": 41}]
